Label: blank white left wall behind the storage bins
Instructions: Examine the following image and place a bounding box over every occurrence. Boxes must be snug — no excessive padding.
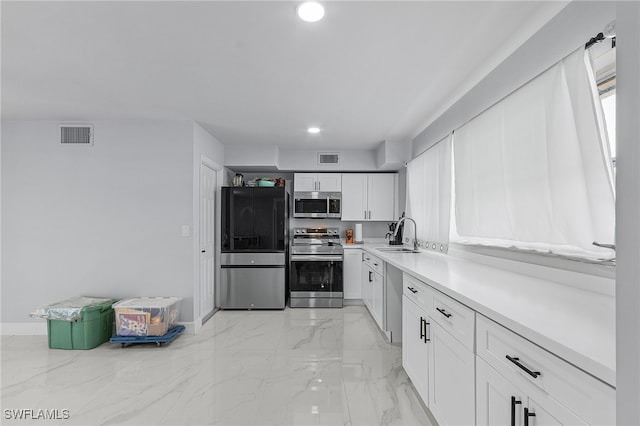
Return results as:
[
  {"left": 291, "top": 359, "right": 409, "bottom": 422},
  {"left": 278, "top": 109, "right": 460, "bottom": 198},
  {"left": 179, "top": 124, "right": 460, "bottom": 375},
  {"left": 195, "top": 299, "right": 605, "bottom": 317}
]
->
[{"left": 1, "top": 120, "right": 194, "bottom": 323}]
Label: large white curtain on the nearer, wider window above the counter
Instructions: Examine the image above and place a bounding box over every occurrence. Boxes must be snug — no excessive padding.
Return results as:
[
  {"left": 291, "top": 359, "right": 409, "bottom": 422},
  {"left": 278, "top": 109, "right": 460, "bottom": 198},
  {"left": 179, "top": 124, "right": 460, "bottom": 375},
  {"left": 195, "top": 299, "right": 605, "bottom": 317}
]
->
[{"left": 452, "top": 49, "right": 615, "bottom": 259}]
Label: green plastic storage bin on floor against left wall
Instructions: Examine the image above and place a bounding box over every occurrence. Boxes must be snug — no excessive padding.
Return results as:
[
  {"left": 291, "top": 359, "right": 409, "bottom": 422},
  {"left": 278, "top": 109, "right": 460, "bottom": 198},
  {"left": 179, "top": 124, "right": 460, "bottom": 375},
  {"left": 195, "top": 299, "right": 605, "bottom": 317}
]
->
[{"left": 47, "top": 300, "right": 116, "bottom": 349}]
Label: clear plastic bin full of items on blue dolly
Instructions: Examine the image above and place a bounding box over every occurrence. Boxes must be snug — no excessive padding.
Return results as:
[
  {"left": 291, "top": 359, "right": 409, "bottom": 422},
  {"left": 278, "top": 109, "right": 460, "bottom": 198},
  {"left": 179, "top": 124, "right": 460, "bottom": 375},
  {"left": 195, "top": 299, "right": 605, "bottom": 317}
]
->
[{"left": 113, "top": 297, "right": 182, "bottom": 336}]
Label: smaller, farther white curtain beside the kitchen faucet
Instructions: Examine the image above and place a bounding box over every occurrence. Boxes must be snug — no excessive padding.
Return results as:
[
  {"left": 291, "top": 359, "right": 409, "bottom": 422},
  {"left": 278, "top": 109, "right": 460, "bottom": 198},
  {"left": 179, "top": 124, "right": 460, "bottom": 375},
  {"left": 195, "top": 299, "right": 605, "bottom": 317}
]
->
[{"left": 405, "top": 136, "right": 451, "bottom": 250}]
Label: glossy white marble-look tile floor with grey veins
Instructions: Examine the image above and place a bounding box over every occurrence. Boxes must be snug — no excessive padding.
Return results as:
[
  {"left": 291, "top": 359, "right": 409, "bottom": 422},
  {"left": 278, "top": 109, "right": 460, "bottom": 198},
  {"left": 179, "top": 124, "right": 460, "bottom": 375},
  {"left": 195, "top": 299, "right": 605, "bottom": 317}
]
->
[{"left": 0, "top": 306, "right": 431, "bottom": 426}]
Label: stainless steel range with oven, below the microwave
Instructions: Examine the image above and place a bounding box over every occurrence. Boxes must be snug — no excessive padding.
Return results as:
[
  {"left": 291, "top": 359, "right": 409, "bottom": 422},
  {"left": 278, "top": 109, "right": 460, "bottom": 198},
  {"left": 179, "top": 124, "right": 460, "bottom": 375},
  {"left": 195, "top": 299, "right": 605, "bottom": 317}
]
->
[{"left": 289, "top": 228, "right": 344, "bottom": 308}]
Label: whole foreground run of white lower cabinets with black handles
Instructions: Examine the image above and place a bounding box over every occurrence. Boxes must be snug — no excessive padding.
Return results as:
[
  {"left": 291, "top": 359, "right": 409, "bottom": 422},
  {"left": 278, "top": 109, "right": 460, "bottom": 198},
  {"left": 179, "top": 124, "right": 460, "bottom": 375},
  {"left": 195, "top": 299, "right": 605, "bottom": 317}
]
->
[{"left": 402, "top": 273, "right": 616, "bottom": 426}]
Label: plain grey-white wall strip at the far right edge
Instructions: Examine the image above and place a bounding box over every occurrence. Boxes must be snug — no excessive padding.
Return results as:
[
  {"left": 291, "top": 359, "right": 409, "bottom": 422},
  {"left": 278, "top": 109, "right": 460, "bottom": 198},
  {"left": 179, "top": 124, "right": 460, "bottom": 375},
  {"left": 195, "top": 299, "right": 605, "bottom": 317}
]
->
[{"left": 616, "top": 1, "right": 640, "bottom": 425}]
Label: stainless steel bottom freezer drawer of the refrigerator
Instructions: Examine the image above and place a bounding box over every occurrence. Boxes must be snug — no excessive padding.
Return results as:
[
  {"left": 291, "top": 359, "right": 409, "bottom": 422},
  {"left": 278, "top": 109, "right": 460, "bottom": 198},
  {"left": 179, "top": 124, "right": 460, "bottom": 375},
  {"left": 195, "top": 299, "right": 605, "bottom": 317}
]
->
[{"left": 220, "top": 266, "right": 286, "bottom": 309}]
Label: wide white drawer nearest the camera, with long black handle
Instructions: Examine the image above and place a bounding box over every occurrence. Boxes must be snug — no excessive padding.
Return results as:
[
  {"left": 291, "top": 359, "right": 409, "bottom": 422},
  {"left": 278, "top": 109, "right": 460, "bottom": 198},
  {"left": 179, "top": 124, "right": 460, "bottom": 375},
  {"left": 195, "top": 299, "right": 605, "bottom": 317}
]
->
[{"left": 476, "top": 315, "right": 615, "bottom": 424}]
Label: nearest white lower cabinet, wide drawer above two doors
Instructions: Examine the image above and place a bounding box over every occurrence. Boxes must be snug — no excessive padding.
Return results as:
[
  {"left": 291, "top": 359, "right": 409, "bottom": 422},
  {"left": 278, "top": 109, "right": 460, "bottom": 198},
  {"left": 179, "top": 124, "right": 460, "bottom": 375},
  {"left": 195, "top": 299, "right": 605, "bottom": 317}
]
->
[{"left": 476, "top": 315, "right": 616, "bottom": 426}]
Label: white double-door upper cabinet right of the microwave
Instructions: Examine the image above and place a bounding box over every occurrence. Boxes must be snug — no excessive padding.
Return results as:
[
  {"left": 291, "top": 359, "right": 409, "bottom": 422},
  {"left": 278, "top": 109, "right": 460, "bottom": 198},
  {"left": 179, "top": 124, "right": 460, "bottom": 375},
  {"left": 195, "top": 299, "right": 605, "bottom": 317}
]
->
[{"left": 342, "top": 173, "right": 397, "bottom": 221}]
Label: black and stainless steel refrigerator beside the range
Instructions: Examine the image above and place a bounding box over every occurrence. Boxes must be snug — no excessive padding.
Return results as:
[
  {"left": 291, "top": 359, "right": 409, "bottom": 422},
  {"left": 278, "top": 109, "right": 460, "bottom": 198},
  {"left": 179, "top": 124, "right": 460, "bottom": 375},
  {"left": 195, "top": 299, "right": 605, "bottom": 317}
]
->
[{"left": 218, "top": 187, "right": 289, "bottom": 309}]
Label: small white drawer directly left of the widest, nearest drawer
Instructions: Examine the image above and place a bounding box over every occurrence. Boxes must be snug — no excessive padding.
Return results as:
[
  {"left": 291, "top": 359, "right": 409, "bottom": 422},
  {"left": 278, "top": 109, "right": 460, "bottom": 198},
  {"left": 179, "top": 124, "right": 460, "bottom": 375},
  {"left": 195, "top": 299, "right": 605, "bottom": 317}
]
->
[{"left": 427, "top": 288, "right": 475, "bottom": 352}]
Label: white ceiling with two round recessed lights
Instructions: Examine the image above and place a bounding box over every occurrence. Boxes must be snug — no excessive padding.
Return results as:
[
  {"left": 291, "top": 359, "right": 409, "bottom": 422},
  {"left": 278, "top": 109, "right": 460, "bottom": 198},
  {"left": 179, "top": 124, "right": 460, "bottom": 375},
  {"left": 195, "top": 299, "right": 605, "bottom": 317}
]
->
[{"left": 1, "top": 1, "right": 566, "bottom": 149}]
